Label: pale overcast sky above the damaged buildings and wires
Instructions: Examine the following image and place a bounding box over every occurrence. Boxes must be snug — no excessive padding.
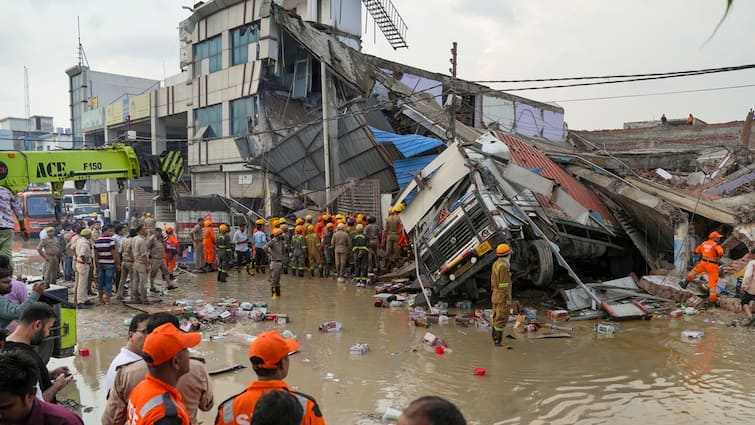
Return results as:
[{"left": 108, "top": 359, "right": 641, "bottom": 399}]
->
[{"left": 0, "top": 0, "right": 755, "bottom": 129}]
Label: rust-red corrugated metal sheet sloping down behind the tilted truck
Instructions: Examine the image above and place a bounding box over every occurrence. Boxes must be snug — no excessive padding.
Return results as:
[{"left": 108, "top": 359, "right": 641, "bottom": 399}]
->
[{"left": 495, "top": 131, "right": 616, "bottom": 225}]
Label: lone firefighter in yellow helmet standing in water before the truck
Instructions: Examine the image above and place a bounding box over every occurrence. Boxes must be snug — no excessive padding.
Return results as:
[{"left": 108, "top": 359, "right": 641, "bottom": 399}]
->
[{"left": 490, "top": 243, "right": 512, "bottom": 347}]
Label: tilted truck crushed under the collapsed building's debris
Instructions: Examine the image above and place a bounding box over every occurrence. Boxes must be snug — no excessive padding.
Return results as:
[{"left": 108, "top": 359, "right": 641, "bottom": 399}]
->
[{"left": 395, "top": 133, "right": 632, "bottom": 300}]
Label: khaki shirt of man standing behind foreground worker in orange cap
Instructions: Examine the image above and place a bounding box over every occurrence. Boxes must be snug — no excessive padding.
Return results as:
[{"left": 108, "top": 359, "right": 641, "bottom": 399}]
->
[{"left": 102, "top": 357, "right": 214, "bottom": 425}]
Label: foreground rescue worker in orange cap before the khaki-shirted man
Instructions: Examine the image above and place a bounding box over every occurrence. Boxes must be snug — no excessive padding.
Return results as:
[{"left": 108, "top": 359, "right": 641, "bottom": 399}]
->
[{"left": 126, "top": 323, "right": 202, "bottom": 425}]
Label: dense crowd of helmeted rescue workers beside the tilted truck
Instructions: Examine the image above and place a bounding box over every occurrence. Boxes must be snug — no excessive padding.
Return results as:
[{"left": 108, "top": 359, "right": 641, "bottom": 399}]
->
[{"left": 190, "top": 204, "right": 409, "bottom": 297}]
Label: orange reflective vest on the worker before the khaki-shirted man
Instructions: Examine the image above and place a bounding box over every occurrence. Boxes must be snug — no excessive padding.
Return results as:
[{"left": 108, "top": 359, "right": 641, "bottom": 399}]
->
[{"left": 126, "top": 374, "right": 191, "bottom": 425}]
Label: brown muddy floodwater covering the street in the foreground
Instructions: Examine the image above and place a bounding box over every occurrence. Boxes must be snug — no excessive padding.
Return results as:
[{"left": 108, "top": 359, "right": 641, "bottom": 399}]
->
[{"left": 38, "top": 262, "right": 755, "bottom": 425}]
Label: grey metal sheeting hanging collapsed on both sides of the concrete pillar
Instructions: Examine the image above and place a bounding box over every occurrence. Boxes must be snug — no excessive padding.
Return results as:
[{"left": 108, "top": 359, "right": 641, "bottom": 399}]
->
[{"left": 267, "top": 115, "right": 398, "bottom": 200}]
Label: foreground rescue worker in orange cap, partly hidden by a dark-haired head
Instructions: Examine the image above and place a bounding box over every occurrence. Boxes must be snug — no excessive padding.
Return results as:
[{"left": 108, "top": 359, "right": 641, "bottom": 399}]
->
[{"left": 215, "top": 331, "right": 325, "bottom": 425}]
